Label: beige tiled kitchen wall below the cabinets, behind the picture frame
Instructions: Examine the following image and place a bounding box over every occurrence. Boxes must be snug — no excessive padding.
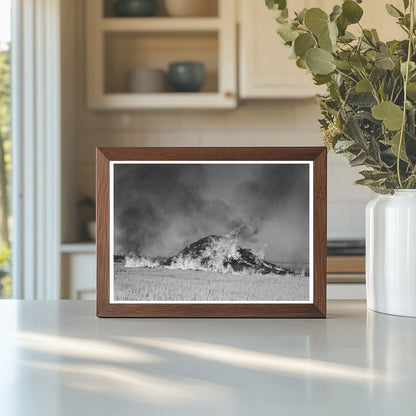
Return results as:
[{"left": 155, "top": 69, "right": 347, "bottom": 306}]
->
[{"left": 63, "top": 0, "right": 372, "bottom": 241}]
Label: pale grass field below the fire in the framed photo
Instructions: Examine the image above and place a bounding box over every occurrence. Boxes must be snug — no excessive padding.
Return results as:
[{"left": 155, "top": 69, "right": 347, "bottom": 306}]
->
[{"left": 114, "top": 264, "right": 309, "bottom": 302}]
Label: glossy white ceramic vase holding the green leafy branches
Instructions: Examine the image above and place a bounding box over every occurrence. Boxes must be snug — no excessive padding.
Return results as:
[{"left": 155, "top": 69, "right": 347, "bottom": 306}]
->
[{"left": 366, "top": 190, "right": 416, "bottom": 317}]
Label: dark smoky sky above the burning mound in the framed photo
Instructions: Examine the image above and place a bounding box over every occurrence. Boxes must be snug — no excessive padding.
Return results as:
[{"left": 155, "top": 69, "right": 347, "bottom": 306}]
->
[{"left": 114, "top": 164, "right": 309, "bottom": 262}]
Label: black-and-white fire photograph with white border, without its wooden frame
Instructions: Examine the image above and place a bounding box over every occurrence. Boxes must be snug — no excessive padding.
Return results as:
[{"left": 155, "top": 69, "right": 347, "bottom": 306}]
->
[{"left": 110, "top": 161, "right": 313, "bottom": 303}]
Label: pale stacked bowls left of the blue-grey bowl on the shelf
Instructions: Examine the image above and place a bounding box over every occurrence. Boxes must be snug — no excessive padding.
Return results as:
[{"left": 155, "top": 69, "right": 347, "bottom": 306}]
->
[{"left": 128, "top": 68, "right": 168, "bottom": 94}]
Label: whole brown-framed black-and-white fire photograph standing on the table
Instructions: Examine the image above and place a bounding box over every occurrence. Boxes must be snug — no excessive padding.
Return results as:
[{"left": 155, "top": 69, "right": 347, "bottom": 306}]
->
[{"left": 97, "top": 147, "right": 327, "bottom": 318}]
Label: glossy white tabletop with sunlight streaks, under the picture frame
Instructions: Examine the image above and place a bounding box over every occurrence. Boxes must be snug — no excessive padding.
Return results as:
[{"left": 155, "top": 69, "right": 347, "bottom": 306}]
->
[{"left": 0, "top": 301, "right": 416, "bottom": 416}]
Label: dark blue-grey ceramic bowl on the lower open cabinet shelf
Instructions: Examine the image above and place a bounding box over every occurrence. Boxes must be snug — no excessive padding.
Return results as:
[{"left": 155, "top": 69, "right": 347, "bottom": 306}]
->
[{"left": 169, "top": 61, "right": 205, "bottom": 92}]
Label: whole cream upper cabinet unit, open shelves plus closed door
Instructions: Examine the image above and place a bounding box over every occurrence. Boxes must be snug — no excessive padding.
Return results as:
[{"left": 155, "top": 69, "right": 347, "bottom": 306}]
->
[{"left": 86, "top": 0, "right": 403, "bottom": 110}]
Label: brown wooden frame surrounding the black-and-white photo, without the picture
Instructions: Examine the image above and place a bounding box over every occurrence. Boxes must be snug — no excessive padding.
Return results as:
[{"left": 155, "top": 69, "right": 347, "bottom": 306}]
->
[{"left": 96, "top": 147, "right": 327, "bottom": 318}]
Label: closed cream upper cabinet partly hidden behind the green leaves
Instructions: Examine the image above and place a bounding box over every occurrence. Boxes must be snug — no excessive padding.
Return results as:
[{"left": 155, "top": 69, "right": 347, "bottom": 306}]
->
[{"left": 238, "top": 0, "right": 404, "bottom": 99}]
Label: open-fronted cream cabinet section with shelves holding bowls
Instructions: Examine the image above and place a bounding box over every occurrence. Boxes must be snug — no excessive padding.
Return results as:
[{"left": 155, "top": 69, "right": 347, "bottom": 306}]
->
[{"left": 86, "top": 0, "right": 237, "bottom": 110}]
